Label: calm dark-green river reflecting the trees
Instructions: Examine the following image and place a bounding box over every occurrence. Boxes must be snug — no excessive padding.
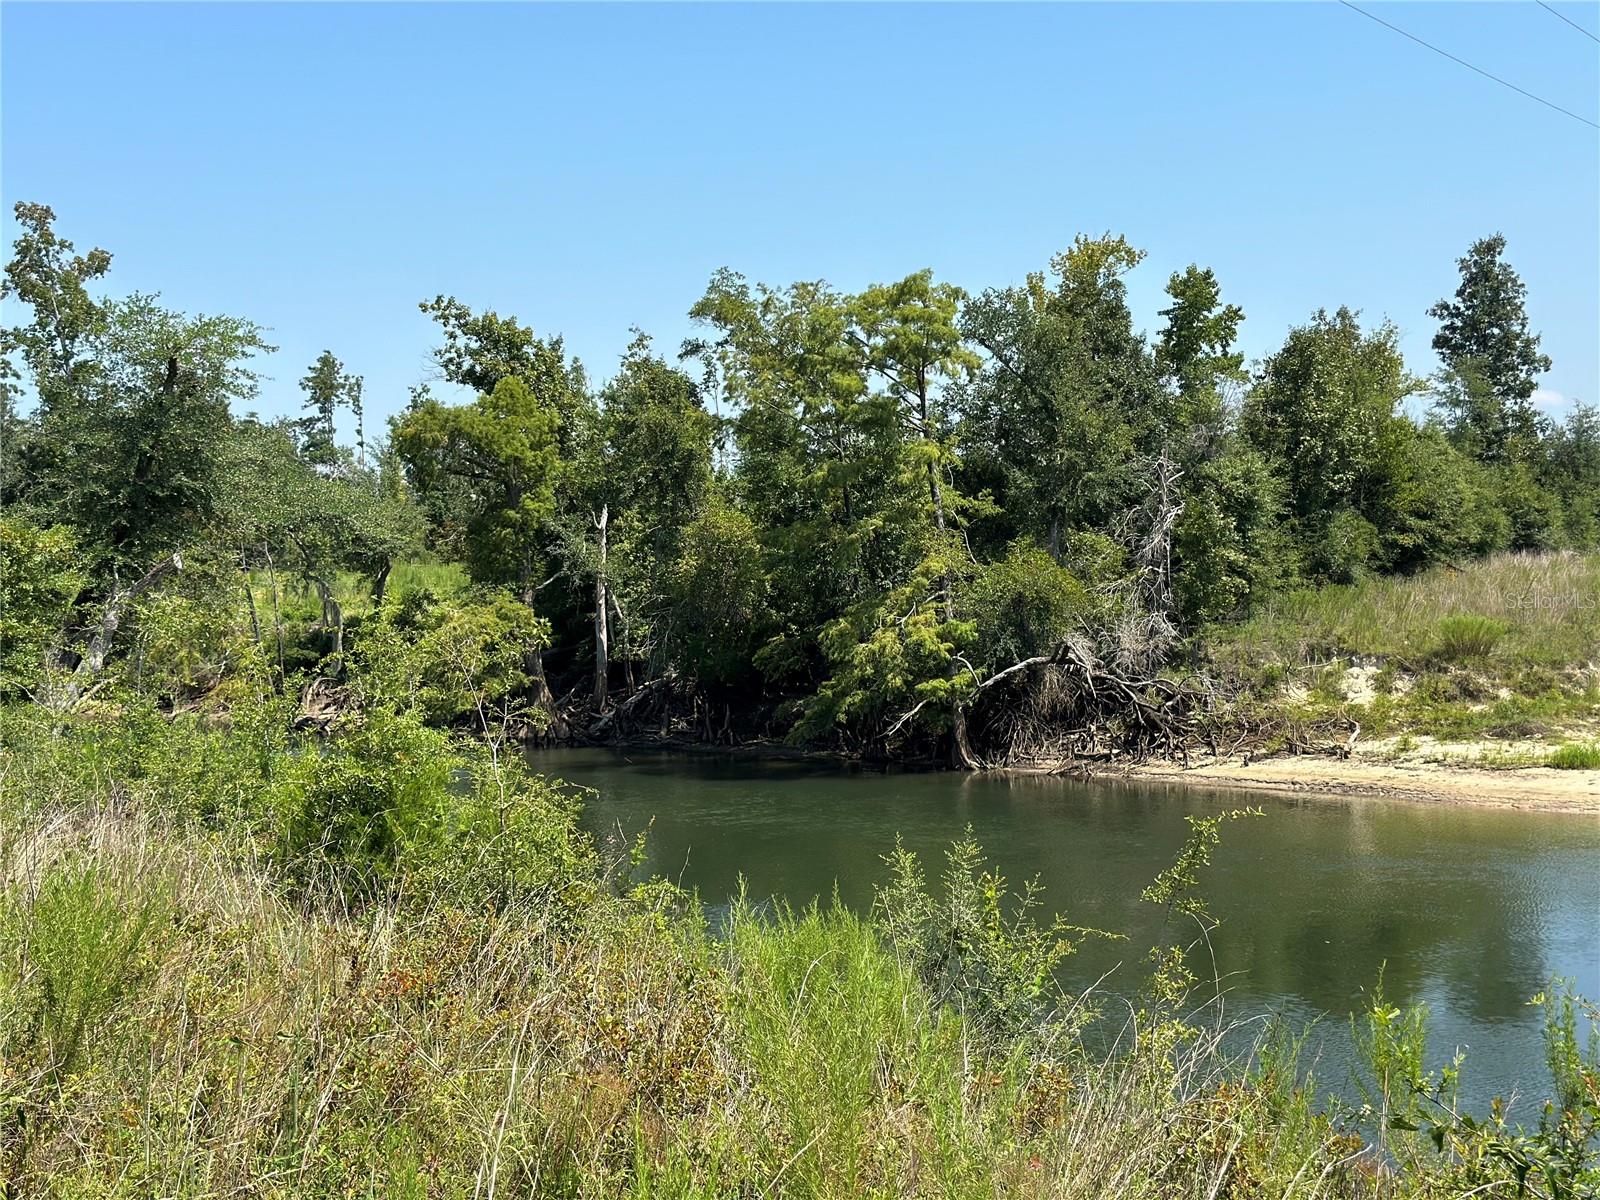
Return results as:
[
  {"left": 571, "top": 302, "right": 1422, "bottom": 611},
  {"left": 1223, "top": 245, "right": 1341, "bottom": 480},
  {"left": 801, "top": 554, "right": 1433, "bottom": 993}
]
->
[{"left": 534, "top": 750, "right": 1600, "bottom": 1120}]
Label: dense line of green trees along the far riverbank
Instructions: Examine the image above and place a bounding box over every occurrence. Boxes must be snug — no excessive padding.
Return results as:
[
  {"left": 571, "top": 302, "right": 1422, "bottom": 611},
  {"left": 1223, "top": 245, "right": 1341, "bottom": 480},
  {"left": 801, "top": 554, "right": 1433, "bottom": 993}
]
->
[{"left": 0, "top": 203, "right": 1600, "bottom": 763}]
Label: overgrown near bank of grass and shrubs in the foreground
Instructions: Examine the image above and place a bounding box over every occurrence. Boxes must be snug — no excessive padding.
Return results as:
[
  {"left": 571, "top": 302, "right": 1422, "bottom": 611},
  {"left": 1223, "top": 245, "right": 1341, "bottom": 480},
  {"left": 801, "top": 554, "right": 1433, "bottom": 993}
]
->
[{"left": 0, "top": 698, "right": 1597, "bottom": 1197}]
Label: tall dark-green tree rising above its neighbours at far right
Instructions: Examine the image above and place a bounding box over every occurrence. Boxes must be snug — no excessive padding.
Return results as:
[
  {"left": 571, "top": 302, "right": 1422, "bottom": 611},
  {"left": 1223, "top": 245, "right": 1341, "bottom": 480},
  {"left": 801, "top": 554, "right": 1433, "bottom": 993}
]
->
[{"left": 1427, "top": 234, "right": 1550, "bottom": 462}]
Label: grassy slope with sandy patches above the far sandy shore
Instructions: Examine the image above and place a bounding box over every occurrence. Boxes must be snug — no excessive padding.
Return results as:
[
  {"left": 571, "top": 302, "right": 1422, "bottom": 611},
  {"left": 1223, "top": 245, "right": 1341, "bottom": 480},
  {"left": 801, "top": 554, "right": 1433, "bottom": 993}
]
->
[{"left": 1203, "top": 554, "right": 1600, "bottom": 770}]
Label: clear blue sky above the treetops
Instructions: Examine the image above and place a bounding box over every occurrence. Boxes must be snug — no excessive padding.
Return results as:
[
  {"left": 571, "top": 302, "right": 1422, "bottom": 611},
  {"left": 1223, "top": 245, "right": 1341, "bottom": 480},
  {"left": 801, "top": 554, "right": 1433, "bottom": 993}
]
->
[{"left": 0, "top": 3, "right": 1600, "bottom": 438}]
